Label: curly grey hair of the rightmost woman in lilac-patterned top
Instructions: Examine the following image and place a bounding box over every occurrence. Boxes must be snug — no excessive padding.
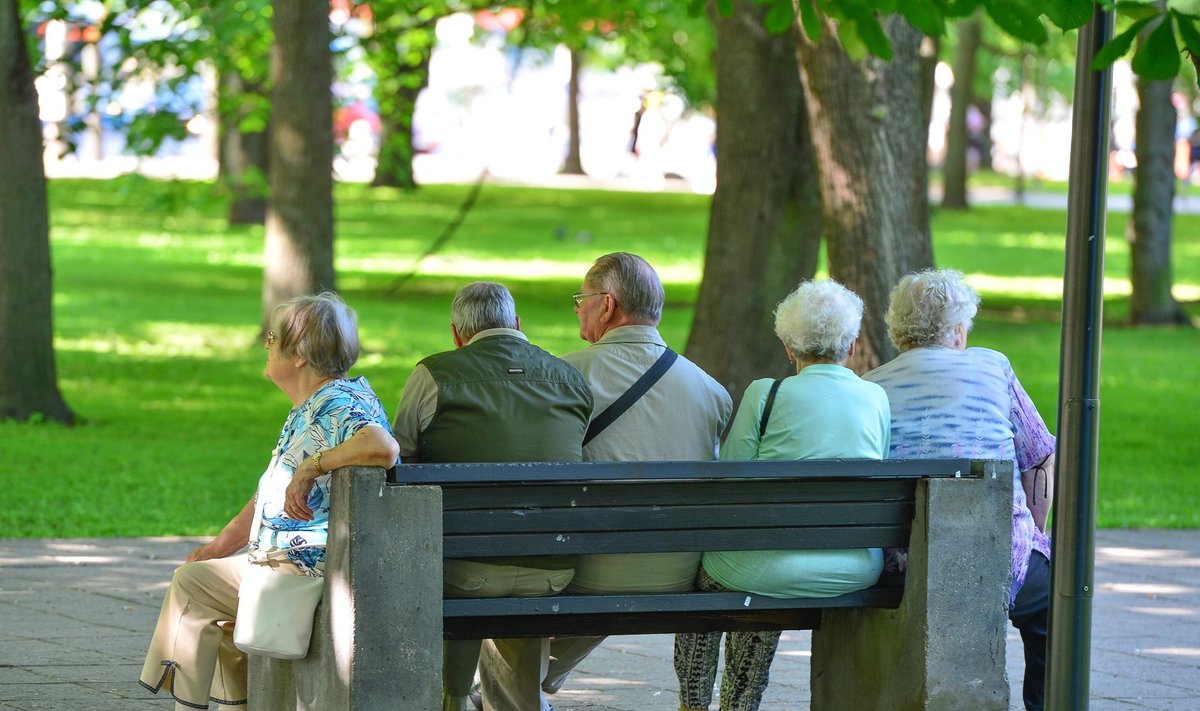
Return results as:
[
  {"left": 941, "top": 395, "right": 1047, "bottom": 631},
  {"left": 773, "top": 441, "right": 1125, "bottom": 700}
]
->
[{"left": 883, "top": 269, "right": 979, "bottom": 351}]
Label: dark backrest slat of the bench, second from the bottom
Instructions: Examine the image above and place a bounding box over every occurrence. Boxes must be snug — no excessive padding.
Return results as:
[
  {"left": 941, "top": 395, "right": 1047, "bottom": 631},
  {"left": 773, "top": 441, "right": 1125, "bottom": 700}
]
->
[{"left": 443, "top": 502, "right": 913, "bottom": 534}]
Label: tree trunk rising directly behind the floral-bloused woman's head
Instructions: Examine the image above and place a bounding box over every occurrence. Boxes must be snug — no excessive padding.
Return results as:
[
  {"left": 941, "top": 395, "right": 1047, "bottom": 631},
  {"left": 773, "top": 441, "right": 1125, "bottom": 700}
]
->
[{"left": 263, "top": 0, "right": 334, "bottom": 324}]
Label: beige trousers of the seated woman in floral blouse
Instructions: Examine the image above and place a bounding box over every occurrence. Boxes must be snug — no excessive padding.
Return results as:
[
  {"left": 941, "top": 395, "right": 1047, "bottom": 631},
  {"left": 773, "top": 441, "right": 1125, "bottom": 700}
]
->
[{"left": 140, "top": 554, "right": 250, "bottom": 710}]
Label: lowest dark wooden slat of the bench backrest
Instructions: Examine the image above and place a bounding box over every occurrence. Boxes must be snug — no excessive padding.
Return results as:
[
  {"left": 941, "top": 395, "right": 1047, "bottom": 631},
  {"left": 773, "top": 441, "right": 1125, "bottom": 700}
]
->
[{"left": 443, "top": 524, "right": 910, "bottom": 558}]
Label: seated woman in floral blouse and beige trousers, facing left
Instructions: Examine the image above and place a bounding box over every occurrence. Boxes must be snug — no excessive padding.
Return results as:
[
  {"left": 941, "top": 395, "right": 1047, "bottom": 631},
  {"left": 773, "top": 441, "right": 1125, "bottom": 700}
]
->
[{"left": 140, "top": 292, "right": 398, "bottom": 710}]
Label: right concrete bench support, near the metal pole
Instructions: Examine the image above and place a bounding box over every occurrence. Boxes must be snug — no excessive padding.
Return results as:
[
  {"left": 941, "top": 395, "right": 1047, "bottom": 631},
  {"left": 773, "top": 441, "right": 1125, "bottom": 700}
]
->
[{"left": 811, "top": 462, "right": 1013, "bottom": 711}]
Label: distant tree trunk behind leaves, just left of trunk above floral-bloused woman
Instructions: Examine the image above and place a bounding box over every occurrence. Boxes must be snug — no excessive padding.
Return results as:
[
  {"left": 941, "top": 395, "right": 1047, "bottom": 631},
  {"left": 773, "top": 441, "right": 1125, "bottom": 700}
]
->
[{"left": 217, "top": 70, "right": 269, "bottom": 225}]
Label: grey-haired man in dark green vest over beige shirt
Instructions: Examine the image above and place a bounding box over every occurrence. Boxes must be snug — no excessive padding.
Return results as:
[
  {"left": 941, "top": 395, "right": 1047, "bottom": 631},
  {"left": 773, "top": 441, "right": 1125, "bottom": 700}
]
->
[{"left": 392, "top": 282, "right": 592, "bottom": 711}]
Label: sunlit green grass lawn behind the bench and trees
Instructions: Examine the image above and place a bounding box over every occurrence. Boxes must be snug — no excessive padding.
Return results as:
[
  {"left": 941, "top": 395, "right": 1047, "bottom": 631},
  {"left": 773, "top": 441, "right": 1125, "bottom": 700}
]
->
[{"left": 0, "top": 179, "right": 1200, "bottom": 537}]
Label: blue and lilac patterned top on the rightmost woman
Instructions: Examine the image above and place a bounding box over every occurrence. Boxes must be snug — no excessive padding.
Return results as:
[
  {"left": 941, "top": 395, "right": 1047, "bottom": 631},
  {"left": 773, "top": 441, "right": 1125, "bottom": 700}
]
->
[{"left": 863, "top": 347, "right": 1055, "bottom": 601}]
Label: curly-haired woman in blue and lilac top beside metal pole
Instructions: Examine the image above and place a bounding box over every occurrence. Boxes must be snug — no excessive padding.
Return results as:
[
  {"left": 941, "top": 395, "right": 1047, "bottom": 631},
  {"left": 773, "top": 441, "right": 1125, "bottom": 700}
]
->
[{"left": 864, "top": 270, "right": 1055, "bottom": 711}]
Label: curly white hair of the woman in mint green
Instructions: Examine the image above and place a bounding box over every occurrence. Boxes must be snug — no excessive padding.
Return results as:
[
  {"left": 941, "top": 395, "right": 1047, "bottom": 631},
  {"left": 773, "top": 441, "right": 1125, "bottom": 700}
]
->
[{"left": 775, "top": 280, "right": 863, "bottom": 363}]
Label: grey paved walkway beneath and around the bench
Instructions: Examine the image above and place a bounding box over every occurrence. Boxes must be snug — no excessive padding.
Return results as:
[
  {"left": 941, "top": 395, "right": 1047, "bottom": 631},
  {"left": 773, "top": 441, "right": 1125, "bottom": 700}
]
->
[{"left": 0, "top": 531, "right": 1200, "bottom": 711}]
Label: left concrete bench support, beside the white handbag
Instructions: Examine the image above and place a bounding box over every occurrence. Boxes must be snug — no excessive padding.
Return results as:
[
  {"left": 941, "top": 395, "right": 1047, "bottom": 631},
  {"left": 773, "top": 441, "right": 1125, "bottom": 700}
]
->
[{"left": 248, "top": 468, "right": 442, "bottom": 711}]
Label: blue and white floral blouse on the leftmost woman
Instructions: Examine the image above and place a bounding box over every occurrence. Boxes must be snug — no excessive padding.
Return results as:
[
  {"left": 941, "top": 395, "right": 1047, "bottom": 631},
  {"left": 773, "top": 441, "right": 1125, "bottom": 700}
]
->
[{"left": 250, "top": 376, "right": 391, "bottom": 576}]
